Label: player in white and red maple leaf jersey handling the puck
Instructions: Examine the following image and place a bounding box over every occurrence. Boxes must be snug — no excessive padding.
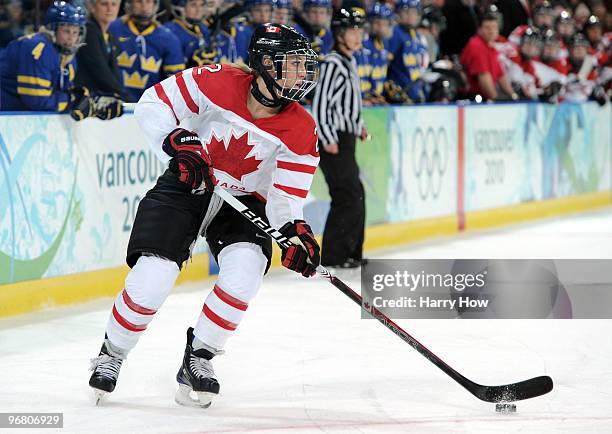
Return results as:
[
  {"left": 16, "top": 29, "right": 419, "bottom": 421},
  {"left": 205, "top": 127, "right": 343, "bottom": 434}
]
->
[{"left": 89, "top": 24, "right": 319, "bottom": 407}]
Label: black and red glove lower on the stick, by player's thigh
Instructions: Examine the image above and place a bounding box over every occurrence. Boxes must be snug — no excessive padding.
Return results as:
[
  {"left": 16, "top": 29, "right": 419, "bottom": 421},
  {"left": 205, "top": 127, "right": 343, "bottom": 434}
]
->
[{"left": 278, "top": 220, "right": 321, "bottom": 277}]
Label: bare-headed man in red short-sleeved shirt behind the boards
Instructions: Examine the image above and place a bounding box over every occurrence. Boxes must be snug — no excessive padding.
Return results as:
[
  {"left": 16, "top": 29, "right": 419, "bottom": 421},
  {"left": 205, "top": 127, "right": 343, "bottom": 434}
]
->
[{"left": 460, "top": 12, "right": 518, "bottom": 100}]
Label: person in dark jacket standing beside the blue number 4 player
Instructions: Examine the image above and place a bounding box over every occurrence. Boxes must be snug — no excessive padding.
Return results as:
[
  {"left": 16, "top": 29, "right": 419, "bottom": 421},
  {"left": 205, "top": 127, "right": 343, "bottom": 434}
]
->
[{"left": 75, "top": 0, "right": 130, "bottom": 117}]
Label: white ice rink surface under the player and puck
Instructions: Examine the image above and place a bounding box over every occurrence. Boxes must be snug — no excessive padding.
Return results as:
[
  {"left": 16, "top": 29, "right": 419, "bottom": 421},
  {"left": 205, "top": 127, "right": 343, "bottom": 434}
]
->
[{"left": 0, "top": 209, "right": 612, "bottom": 434}]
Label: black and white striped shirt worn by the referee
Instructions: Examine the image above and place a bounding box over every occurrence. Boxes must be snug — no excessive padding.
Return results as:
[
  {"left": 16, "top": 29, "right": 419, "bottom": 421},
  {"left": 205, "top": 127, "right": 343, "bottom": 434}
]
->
[{"left": 312, "top": 51, "right": 362, "bottom": 145}]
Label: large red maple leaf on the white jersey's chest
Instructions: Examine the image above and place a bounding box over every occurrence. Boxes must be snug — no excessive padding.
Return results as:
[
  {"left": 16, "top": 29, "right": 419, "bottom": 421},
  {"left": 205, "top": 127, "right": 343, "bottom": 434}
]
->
[{"left": 207, "top": 131, "right": 262, "bottom": 182}]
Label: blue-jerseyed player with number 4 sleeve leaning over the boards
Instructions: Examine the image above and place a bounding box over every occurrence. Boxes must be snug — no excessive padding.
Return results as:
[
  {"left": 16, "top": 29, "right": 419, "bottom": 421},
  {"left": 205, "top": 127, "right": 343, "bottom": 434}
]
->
[{"left": 0, "top": 1, "right": 95, "bottom": 120}]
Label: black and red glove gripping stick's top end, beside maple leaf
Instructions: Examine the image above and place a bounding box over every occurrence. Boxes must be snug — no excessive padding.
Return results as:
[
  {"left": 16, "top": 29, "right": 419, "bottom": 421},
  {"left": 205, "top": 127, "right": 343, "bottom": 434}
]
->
[{"left": 162, "top": 128, "right": 217, "bottom": 194}]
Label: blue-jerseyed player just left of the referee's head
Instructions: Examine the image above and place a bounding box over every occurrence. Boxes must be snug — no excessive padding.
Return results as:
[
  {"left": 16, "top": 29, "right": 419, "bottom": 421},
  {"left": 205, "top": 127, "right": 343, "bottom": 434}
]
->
[{"left": 295, "top": 0, "right": 334, "bottom": 55}]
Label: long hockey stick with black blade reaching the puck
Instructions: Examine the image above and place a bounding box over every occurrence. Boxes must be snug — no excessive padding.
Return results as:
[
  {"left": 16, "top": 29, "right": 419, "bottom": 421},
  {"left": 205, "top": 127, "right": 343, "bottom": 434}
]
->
[{"left": 215, "top": 187, "right": 553, "bottom": 402}]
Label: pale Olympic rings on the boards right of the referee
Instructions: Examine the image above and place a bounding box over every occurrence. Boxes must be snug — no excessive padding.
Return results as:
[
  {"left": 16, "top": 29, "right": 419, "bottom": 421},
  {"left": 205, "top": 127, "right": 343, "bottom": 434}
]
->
[{"left": 412, "top": 127, "right": 449, "bottom": 200}]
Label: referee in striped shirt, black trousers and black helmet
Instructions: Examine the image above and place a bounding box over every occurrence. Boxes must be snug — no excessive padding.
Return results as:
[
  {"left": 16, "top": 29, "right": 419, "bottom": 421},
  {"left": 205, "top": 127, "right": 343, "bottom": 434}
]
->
[{"left": 312, "top": 8, "right": 367, "bottom": 268}]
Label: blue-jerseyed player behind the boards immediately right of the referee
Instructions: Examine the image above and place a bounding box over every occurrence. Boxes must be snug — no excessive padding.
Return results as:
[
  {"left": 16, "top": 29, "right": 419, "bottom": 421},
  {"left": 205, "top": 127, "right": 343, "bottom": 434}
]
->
[{"left": 353, "top": 3, "right": 393, "bottom": 105}]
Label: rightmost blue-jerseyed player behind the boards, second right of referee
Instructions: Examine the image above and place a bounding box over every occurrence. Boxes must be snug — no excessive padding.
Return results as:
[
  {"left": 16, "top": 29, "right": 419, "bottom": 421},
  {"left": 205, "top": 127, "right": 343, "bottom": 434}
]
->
[{"left": 385, "top": 0, "right": 429, "bottom": 102}]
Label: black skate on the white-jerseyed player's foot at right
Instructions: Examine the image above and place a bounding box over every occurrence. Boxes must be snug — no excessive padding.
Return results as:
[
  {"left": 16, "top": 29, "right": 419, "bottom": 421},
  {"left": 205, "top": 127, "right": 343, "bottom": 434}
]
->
[{"left": 174, "top": 327, "right": 219, "bottom": 408}]
